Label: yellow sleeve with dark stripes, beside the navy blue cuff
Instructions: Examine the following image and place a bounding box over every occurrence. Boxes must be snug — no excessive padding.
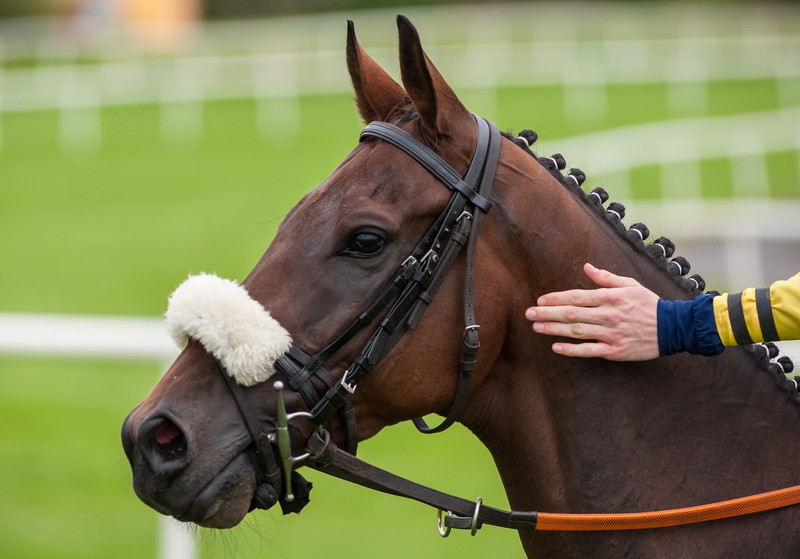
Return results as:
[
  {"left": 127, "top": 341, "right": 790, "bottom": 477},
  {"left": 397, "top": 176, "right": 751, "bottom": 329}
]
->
[{"left": 714, "top": 273, "right": 800, "bottom": 346}]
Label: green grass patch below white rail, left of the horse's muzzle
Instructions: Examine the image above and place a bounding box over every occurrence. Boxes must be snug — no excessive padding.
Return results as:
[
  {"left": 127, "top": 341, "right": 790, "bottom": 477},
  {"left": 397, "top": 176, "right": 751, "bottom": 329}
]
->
[{"left": 0, "top": 358, "right": 158, "bottom": 559}]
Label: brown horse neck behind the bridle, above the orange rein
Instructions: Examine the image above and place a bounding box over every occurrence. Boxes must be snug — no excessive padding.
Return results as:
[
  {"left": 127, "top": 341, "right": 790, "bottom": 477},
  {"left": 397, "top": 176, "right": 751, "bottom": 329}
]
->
[{"left": 465, "top": 147, "right": 800, "bottom": 524}]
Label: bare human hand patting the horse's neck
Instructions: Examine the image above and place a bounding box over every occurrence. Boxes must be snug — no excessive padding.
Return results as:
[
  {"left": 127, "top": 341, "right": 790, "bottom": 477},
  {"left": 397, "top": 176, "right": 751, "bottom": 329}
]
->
[{"left": 525, "top": 264, "right": 659, "bottom": 361}]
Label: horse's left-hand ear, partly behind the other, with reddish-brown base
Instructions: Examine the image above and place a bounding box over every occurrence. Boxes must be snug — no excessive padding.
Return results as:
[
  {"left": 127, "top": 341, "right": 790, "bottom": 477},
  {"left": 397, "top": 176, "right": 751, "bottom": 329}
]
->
[{"left": 347, "top": 20, "right": 407, "bottom": 123}]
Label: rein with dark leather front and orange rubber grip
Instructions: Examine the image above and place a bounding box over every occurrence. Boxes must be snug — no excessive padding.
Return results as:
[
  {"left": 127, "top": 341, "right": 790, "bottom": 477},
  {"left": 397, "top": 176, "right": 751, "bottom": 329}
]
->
[{"left": 307, "top": 432, "right": 800, "bottom": 535}]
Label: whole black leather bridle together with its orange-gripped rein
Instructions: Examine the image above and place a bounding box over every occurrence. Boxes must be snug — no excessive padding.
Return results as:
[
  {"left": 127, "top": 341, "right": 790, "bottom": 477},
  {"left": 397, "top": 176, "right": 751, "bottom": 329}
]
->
[{"left": 220, "top": 116, "right": 800, "bottom": 536}]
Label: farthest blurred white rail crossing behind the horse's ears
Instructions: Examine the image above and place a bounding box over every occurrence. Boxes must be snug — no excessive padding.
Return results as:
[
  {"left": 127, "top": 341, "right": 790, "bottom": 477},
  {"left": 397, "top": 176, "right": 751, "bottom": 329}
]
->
[{"left": 0, "top": 36, "right": 800, "bottom": 113}]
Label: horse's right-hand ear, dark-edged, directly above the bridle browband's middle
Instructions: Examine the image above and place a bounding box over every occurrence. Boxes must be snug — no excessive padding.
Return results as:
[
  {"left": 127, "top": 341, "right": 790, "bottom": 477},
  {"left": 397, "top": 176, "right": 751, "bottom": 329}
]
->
[{"left": 397, "top": 15, "right": 472, "bottom": 135}]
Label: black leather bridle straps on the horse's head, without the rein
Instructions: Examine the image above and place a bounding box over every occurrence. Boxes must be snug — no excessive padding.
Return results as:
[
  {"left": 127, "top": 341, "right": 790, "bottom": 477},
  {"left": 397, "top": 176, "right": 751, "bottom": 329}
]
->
[{"left": 223, "top": 115, "right": 501, "bottom": 512}]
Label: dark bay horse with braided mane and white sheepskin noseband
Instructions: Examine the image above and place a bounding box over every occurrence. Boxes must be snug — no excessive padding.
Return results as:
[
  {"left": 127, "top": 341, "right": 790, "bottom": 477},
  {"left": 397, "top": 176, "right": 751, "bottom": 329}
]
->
[{"left": 122, "top": 16, "right": 800, "bottom": 558}]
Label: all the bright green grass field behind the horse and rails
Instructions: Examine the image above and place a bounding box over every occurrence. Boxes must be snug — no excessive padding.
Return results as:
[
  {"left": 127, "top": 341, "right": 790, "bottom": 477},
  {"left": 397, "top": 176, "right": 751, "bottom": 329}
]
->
[{"left": 0, "top": 8, "right": 800, "bottom": 559}]
